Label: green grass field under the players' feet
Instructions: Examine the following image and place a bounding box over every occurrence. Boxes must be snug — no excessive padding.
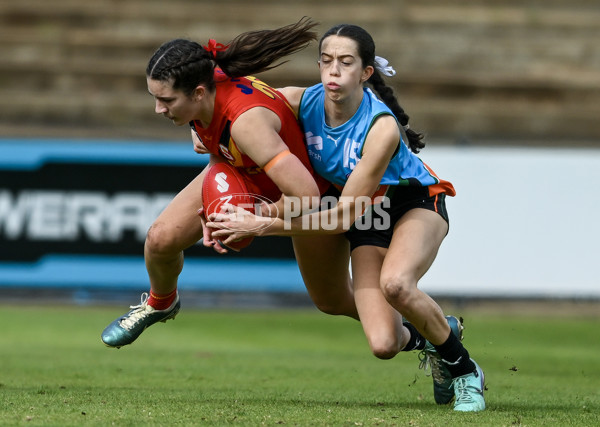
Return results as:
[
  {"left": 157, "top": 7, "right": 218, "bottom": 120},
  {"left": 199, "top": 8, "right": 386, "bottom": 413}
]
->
[{"left": 0, "top": 306, "right": 600, "bottom": 427}]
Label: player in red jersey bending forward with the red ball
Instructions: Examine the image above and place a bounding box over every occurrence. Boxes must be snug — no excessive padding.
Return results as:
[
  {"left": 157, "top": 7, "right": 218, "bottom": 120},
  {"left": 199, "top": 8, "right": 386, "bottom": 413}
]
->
[{"left": 102, "top": 19, "right": 320, "bottom": 348}]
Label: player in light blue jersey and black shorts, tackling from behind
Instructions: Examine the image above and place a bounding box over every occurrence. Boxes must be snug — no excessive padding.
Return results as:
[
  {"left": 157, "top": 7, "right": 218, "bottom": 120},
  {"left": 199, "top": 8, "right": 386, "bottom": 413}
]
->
[{"left": 208, "top": 25, "right": 485, "bottom": 412}]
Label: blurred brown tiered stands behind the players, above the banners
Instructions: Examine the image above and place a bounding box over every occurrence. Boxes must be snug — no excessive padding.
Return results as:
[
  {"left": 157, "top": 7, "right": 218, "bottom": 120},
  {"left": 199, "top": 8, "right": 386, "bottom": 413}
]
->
[{"left": 0, "top": 0, "right": 600, "bottom": 145}]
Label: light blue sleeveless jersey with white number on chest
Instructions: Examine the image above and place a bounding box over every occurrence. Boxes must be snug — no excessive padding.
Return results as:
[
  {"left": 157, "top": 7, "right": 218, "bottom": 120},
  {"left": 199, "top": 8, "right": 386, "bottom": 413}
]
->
[{"left": 299, "top": 84, "right": 440, "bottom": 186}]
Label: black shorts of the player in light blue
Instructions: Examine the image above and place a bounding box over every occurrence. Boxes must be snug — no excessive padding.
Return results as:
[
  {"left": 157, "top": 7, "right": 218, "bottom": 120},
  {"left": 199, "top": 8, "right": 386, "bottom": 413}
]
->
[{"left": 345, "top": 186, "right": 449, "bottom": 250}]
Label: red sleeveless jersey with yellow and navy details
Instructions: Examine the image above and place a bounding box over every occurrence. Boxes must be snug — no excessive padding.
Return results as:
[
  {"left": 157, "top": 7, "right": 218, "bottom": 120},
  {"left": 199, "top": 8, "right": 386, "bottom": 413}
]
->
[{"left": 190, "top": 68, "right": 324, "bottom": 200}]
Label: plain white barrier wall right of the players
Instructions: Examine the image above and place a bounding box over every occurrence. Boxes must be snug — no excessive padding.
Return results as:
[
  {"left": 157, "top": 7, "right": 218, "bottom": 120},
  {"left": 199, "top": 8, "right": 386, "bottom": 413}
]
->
[{"left": 420, "top": 144, "right": 600, "bottom": 298}]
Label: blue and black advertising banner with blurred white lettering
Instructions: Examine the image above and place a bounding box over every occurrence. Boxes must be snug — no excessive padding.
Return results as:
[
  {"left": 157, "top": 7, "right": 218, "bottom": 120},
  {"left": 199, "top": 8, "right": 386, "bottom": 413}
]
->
[{"left": 0, "top": 139, "right": 304, "bottom": 291}]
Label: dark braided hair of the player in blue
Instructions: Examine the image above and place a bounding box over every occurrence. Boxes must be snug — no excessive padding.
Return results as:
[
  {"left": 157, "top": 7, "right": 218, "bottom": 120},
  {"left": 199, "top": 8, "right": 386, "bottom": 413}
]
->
[{"left": 319, "top": 24, "right": 425, "bottom": 153}]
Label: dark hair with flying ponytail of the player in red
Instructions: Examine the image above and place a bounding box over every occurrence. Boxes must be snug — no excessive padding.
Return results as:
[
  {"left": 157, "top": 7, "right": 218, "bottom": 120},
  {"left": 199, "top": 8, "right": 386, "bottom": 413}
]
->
[{"left": 146, "top": 17, "right": 318, "bottom": 95}]
